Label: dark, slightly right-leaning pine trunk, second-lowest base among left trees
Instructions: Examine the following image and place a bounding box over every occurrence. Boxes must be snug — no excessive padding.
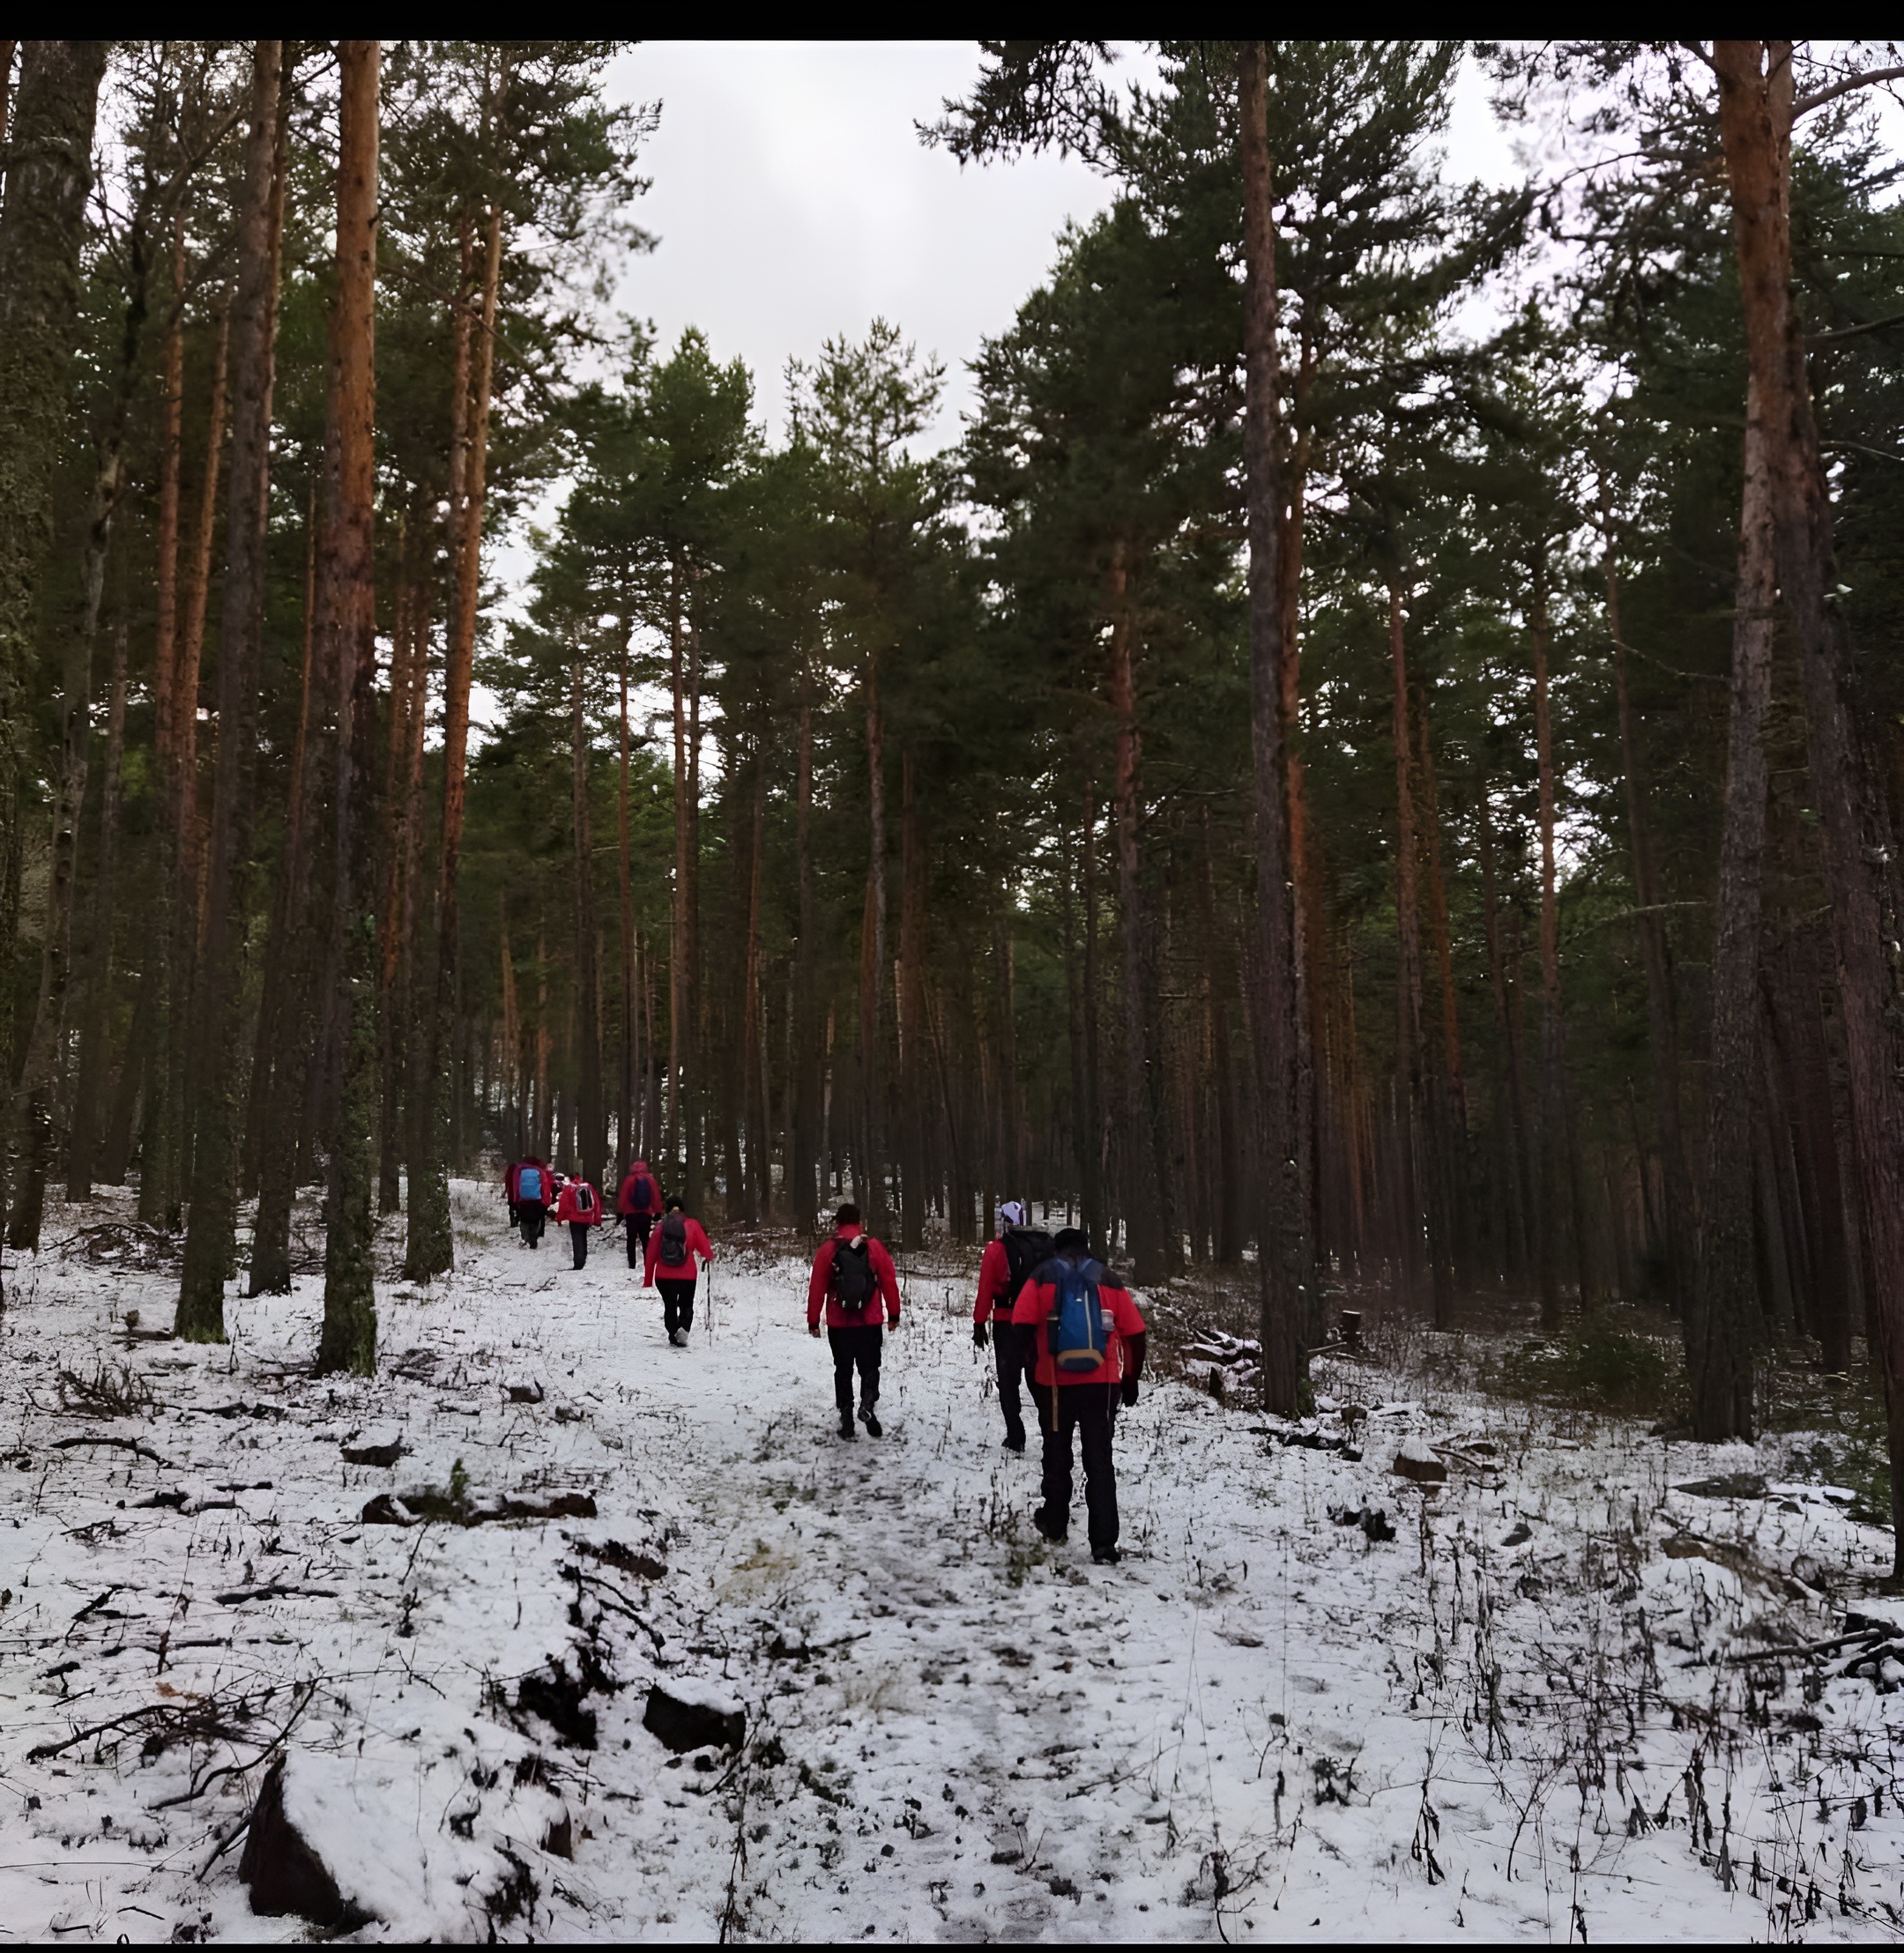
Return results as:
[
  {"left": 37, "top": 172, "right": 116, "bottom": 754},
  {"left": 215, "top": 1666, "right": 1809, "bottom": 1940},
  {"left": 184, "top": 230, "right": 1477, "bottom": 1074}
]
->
[{"left": 174, "top": 41, "right": 283, "bottom": 1341}]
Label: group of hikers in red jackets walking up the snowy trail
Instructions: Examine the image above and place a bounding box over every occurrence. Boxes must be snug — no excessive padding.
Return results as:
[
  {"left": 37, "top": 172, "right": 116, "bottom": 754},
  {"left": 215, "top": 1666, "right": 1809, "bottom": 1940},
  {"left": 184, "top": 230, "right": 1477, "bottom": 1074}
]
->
[{"left": 504, "top": 1158, "right": 1146, "bottom": 1566}]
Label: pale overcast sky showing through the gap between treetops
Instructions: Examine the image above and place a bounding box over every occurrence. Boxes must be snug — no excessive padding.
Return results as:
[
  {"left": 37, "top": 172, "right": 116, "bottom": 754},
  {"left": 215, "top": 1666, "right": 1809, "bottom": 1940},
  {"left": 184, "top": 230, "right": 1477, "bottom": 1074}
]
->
[{"left": 593, "top": 41, "right": 1509, "bottom": 440}]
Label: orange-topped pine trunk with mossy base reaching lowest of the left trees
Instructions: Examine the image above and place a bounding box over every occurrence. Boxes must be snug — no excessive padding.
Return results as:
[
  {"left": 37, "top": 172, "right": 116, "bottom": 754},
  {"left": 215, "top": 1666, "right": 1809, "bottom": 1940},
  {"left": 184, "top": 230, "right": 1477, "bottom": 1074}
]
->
[{"left": 316, "top": 30, "right": 383, "bottom": 1377}]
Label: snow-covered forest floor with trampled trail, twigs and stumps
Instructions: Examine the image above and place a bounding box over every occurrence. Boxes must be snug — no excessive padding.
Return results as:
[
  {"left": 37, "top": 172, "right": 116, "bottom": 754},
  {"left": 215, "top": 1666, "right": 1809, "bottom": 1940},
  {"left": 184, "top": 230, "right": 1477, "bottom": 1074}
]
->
[{"left": 0, "top": 1185, "right": 1904, "bottom": 1939}]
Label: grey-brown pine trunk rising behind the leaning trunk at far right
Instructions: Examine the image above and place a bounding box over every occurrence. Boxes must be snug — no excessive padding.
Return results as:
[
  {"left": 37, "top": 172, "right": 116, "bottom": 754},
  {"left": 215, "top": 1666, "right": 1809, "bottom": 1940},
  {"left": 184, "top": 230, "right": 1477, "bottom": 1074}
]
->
[{"left": 1685, "top": 389, "right": 1777, "bottom": 1444}]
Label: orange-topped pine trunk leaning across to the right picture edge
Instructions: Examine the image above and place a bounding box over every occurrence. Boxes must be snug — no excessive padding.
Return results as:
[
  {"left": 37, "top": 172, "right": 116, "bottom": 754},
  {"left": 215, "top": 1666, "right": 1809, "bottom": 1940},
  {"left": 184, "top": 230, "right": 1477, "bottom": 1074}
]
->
[{"left": 1713, "top": 41, "right": 1904, "bottom": 1576}]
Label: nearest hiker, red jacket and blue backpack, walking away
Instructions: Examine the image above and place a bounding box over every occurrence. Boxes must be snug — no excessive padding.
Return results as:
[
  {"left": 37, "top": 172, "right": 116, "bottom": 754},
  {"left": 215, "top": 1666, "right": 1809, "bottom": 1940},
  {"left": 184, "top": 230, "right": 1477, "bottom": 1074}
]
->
[{"left": 1012, "top": 1227, "right": 1146, "bottom": 1566}]
